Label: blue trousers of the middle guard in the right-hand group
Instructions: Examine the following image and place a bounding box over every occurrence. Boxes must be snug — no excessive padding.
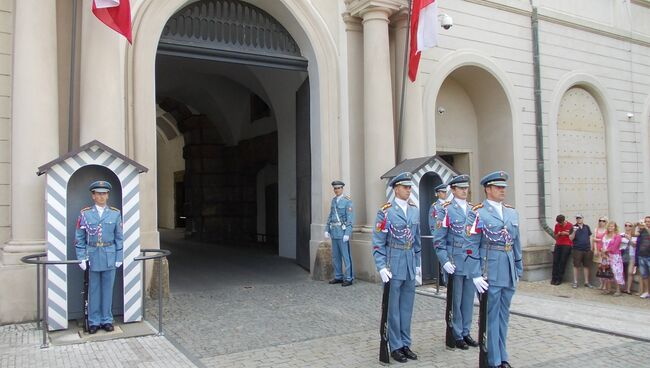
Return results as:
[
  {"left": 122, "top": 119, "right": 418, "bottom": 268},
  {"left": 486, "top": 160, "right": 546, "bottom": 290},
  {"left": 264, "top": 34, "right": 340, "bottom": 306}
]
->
[{"left": 451, "top": 274, "right": 476, "bottom": 340}]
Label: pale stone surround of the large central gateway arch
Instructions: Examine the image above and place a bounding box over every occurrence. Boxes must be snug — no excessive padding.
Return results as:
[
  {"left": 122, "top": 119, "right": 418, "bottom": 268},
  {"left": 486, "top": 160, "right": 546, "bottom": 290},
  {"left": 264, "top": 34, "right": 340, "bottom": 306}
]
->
[{"left": 126, "top": 0, "right": 340, "bottom": 264}]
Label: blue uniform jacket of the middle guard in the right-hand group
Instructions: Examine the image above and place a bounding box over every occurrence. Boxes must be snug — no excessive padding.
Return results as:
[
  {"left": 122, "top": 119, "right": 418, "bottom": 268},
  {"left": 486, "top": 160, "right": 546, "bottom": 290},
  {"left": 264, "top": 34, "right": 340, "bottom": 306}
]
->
[{"left": 430, "top": 200, "right": 479, "bottom": 276}]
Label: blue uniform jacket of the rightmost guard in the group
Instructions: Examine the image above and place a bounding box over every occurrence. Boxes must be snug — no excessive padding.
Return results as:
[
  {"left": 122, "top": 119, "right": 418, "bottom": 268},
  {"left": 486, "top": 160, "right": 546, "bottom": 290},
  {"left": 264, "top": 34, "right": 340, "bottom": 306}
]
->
[{"left": 466, "top": 200, "right": 523, "bottom": 287}]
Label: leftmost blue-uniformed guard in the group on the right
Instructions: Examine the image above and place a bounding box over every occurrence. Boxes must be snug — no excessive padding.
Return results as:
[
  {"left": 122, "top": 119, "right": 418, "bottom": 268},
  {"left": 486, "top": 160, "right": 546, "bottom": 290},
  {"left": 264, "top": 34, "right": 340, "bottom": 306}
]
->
[{"left": 372, "top": 172, "right": 422, "bottom": 363}]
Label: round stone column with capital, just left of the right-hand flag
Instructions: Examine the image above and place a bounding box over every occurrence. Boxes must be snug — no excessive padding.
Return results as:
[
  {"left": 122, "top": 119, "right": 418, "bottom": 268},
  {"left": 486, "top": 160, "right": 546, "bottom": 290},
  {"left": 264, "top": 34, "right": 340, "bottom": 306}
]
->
[{"left": 359, "top": 6, "right": 395, "bottom": 226}]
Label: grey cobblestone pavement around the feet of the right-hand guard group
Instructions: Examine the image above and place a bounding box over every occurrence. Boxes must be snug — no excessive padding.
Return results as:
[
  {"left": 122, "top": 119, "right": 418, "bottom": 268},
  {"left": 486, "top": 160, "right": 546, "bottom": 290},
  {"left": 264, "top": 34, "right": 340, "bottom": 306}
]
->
[{"left": 143, "top": 281, "right": 650, "bottom": 367}]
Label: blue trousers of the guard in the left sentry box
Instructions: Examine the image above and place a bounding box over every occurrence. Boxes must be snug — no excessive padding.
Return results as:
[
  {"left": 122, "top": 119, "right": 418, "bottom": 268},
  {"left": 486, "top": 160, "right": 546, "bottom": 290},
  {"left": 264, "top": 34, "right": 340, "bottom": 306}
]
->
[{"left": 88, "top": 269, "right": 116, "bottom": 326}]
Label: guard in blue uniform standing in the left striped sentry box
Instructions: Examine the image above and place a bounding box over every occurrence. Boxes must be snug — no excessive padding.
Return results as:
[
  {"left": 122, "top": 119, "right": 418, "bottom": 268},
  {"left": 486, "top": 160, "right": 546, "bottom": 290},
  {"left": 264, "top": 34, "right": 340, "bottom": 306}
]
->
[{"left": 75, "top": 180, "right": 123, "bottom": 334}]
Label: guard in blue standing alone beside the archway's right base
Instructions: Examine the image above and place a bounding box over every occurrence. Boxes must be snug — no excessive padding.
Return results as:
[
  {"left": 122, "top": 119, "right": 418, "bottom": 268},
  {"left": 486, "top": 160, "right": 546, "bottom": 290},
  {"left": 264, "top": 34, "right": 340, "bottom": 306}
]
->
[{"left": 325, "top": 180, "right": 354, "bottom": 286}]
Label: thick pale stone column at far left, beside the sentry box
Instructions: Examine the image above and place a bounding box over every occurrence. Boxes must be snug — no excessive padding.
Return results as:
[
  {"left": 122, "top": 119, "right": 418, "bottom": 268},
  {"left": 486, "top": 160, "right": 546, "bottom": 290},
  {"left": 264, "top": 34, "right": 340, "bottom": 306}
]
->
[{"left": 1, "top": 0, "right": 59, "bottom": 265}]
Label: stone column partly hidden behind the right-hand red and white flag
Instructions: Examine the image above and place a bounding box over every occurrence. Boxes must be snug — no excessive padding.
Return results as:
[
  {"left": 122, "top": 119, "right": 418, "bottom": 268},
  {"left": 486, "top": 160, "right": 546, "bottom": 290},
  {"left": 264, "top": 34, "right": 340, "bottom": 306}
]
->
[{"left": 391, "top": 9, "right": 426, "bottom": 162}]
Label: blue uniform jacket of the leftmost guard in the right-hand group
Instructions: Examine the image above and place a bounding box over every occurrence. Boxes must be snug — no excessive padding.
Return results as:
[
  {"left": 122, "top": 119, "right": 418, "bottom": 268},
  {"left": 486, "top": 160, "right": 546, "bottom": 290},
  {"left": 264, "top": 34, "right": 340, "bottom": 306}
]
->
[{"left": 372, "top": 201, "right": 422, "bottom": 280}]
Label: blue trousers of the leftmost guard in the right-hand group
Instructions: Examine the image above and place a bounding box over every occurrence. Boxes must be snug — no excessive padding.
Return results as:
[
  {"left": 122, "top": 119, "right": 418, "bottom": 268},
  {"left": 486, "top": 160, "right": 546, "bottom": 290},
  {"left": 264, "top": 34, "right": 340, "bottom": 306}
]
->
[{"left": 388, "top": 279, "right": 415, "bottom": 351}]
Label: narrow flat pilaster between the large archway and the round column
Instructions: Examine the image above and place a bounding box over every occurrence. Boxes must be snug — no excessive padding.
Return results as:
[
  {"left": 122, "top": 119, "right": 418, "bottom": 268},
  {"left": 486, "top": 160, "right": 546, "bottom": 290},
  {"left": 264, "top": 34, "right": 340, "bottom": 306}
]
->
[{"left": 342, "top": 13, "right": 374, "bottom": 225}]
